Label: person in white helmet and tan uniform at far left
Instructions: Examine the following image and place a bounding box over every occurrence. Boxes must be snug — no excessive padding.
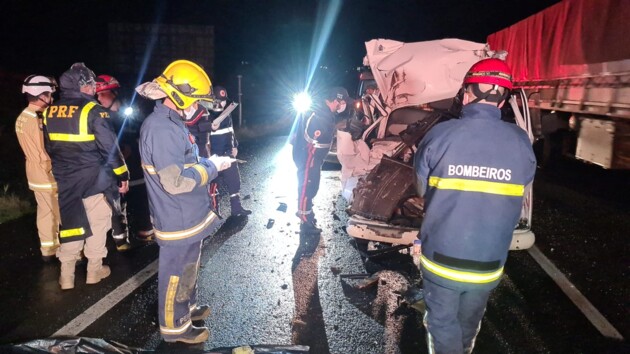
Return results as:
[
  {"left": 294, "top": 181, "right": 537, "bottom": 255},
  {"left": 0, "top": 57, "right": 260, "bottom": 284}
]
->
[{"left": 15, "top": 75, "right": 59, "bottom": 262}]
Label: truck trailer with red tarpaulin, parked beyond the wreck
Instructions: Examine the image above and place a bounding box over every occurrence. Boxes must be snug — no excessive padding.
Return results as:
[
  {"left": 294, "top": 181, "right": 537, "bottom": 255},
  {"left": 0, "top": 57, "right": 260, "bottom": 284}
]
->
[{"left": 488, "top": 0, "right": 630, "bottom": 169}]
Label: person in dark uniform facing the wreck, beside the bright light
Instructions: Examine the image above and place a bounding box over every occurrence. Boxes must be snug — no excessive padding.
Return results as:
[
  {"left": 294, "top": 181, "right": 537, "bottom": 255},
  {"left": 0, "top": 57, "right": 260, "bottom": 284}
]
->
[{"left": 291, "top": 87, "right": 348, "bottom": 233}]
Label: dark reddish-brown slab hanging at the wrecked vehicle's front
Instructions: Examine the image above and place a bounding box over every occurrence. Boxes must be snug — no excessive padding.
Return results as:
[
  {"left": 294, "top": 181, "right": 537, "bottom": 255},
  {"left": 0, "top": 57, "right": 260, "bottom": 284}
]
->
[{"left": 349, "top": 156, "right": 416, "bottom": 221}]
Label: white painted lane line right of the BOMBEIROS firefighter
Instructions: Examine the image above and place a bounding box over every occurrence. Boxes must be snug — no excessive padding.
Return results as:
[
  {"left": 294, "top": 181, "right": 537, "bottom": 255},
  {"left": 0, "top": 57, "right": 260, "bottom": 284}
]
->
[{"left": 528, "top": 245, "right": 623, "bottom": 340}]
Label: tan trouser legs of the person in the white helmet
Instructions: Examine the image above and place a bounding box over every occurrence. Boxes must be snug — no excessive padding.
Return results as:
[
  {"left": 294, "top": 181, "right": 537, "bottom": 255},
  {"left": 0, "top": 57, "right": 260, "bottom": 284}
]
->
[{"left": 33, "top": 190, "right": 59, "bottom": 256}]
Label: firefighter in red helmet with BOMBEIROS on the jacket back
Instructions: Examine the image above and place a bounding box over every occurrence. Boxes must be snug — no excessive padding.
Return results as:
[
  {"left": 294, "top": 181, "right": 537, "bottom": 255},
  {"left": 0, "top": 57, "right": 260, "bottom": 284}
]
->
[{"left": 415, "top": 59, "right": 536, "bottom": 353}]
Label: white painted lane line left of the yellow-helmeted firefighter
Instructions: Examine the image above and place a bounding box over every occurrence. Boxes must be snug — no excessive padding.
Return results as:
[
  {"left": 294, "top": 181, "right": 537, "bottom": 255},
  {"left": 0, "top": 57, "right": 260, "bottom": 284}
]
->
[{"left": 52, "top": 260, "right": 158, "bottom": 337}]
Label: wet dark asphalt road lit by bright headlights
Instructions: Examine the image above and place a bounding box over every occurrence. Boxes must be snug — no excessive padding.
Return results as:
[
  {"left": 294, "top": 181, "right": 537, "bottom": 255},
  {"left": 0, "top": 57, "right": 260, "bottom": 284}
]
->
[{"left": 0, "top": 138, "right": 630, "bottom": 353}]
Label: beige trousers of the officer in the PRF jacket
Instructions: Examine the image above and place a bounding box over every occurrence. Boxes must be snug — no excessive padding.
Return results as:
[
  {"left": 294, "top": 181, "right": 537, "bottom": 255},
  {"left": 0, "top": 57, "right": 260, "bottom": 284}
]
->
[{"left": 57, "top": 193, "right": 112, "bottom": 263}]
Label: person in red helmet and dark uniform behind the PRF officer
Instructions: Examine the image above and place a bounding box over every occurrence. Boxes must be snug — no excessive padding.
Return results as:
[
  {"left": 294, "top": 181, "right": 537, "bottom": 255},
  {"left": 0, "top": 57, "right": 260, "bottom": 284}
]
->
[{"left": 96, "top": 74, "right": 153, "bottom": 246}]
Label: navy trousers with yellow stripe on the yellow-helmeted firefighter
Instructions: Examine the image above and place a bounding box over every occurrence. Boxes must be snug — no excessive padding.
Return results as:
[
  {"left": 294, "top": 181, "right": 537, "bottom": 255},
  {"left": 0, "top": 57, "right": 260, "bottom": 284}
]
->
[{"left": 158, "top": 241, "right": 202, "bottom": 339}]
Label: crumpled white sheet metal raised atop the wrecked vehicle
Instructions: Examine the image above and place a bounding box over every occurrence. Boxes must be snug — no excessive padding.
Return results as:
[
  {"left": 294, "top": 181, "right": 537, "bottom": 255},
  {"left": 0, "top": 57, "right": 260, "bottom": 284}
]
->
[{"left": 363, "top": 38, "right": 491, "bottom": 112}]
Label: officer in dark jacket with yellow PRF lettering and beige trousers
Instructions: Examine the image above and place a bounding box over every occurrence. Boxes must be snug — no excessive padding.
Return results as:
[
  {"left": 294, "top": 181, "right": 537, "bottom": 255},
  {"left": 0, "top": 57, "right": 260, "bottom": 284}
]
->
[{"left": 44, "top": 63, "right": 129, "bottom": 289}]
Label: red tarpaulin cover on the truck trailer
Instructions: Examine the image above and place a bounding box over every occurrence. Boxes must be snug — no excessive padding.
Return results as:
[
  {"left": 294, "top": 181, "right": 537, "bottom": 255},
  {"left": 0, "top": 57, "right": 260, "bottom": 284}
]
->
[{"left": 488, "top": 0, "right": 630, "bottom": 82}]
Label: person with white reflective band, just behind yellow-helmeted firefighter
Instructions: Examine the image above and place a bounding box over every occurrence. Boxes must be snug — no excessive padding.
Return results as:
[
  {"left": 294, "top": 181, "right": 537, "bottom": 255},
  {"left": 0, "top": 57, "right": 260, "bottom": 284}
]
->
[{"left": 210, "top": 86, "right": 252, "bottom": 217}]
